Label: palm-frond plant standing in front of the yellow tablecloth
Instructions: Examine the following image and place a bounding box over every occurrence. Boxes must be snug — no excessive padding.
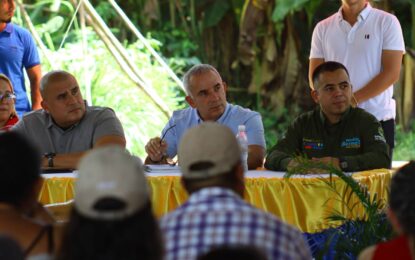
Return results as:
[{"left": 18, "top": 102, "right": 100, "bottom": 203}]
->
[{"left": 285, "top": 157, "right": 393, "bottom": 259}]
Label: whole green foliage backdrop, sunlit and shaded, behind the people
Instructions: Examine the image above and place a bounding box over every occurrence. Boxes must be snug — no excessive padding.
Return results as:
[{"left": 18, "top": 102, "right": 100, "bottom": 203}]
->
[{"left": 15, "top": 0, "right": 415, "bottom": 160}]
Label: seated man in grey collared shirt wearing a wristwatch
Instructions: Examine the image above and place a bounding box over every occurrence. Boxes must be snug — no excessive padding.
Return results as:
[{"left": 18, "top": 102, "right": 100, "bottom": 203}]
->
[{"left": 13, "top": 70, "right": 125, "bottom": 169}]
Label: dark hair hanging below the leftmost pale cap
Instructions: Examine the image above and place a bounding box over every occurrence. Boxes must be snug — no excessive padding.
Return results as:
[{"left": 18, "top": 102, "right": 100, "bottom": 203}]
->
[{"left": 56, "top": 201, "right": 164, "bottom": 260}]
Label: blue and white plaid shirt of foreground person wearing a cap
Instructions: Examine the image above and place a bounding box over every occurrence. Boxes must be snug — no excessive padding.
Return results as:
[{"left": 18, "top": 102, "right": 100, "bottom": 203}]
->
[{"left": 160, "top": 187, "right": 311, "bottom": 260}]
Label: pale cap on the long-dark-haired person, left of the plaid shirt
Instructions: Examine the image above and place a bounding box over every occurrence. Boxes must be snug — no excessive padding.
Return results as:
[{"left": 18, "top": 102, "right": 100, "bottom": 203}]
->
[{"left": 74, "top": 146, "right": 150, "bottom": 220}]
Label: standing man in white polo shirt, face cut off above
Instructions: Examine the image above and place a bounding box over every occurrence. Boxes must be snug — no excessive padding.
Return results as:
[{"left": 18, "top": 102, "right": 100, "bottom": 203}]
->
[{"left": 309, "top": 0, "right": 405, "bottom": 157}]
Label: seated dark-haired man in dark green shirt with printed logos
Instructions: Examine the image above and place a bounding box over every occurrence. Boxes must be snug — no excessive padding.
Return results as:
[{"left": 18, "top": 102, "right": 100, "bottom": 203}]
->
[{"left": 265, "top": 61, "right": 391, "bottom": 172}]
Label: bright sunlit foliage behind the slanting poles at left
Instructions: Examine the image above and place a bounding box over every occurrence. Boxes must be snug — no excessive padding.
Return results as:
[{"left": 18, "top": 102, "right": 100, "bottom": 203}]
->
[{"left": 15, "top": 0, "right": 187, "bottom": 157}]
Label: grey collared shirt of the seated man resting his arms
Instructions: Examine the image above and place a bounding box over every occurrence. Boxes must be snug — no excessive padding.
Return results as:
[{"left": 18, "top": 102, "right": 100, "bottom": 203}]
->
[{"left": 12, "top": 106, "right": 124, "bottom": 154}]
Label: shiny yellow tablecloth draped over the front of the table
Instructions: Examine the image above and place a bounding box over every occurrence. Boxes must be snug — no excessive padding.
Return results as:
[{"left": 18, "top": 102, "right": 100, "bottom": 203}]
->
[{"left": 39, "top": 169, "right": 392, "bottom": 233}]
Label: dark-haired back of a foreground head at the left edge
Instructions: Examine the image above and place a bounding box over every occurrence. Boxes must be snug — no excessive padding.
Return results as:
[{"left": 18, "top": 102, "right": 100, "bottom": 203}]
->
[{"left": 0, "top": 132, "right": 41, "bottom": 206}]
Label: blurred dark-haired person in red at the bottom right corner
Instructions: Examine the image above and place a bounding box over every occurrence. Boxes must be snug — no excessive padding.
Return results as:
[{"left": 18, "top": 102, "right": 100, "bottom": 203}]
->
[{"left": 359, "top": 161, "right": 415, "bottom": 260}]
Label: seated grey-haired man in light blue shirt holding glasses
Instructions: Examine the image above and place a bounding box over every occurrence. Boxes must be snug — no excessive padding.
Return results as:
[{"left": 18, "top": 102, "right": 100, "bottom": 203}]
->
[{"left": 145, "top": 64, "right": 265, "bottom": 169}]
